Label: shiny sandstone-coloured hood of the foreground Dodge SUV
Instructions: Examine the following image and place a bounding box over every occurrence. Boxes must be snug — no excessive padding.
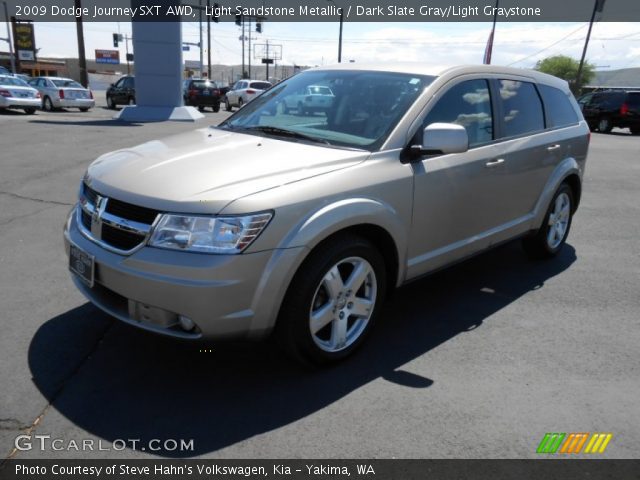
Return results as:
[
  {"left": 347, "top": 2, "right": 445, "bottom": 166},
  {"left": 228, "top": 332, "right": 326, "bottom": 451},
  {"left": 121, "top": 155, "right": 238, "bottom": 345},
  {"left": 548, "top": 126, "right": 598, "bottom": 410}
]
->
[{"left": 85, "top": 128, "right": 369, "bottom": 213}]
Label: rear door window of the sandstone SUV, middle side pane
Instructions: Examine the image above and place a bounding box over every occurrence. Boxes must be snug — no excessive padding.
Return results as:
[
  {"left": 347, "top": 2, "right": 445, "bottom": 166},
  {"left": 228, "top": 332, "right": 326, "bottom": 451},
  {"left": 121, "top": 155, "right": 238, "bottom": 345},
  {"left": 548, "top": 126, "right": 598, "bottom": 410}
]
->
[{"left": 500, "top": 80, "right": 544, "bottom": 137}]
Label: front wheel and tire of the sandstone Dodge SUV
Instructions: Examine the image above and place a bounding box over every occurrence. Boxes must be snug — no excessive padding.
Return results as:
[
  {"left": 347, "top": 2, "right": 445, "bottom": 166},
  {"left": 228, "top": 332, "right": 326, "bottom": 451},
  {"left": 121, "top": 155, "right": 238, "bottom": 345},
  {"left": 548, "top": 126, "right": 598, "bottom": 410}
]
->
[{"left": 275, "top": 234, "right": 386, "bottom": 366}]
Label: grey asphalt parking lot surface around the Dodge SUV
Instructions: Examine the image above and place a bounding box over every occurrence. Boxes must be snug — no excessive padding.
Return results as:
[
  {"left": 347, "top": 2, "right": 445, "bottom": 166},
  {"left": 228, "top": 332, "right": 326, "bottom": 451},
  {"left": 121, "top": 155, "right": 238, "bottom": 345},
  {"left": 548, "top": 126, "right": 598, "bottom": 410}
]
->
[{"left": 0, "top": 93, "right": 640, "bottom": 459}]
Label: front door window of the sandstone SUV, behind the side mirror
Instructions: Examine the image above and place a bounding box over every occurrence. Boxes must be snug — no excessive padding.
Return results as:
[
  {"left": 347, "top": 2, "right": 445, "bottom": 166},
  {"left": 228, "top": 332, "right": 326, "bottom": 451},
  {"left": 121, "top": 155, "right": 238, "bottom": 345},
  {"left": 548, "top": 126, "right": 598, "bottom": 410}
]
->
[{"left": 419, "top": 80, "right": 493, "bottom": 148}]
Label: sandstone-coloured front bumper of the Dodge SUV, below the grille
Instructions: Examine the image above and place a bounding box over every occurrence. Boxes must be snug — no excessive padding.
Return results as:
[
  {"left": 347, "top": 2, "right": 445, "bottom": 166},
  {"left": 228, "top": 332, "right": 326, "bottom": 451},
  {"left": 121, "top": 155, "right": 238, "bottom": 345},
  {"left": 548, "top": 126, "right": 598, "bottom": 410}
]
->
[{"left": 64, "top": 207, "right": 306, "bottom": 339}]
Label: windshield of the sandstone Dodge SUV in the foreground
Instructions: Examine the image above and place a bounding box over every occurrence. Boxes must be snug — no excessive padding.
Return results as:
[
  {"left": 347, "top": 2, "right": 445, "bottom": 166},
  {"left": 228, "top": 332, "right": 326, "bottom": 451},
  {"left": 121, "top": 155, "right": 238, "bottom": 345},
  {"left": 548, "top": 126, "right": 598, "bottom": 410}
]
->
[{"left": 220, "top": 70, "right": 435, "bottom": 151}]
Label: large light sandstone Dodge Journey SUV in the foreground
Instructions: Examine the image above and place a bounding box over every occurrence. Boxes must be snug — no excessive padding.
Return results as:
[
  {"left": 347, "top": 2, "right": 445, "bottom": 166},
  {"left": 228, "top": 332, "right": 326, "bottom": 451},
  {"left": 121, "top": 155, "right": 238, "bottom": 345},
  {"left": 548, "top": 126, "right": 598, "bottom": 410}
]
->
[{"left": 64, "top": 64, "right": 590, "bottom": 364}]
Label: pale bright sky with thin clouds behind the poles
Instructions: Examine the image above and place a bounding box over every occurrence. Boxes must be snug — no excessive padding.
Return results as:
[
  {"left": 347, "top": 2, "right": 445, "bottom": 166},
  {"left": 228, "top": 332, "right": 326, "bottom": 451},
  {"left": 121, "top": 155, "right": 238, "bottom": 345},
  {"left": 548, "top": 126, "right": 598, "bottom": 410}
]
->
[{"left": 7, "top": 21, "right": 640, "bottom": 70}]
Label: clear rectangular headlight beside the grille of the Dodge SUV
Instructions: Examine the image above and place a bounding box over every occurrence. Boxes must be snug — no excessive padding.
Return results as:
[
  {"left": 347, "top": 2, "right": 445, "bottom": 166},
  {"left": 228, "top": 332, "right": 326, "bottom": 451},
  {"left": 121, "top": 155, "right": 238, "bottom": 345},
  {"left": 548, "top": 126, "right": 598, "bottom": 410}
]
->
[{"left": 149, "top": 213, "right": 273, "bottom": 253}]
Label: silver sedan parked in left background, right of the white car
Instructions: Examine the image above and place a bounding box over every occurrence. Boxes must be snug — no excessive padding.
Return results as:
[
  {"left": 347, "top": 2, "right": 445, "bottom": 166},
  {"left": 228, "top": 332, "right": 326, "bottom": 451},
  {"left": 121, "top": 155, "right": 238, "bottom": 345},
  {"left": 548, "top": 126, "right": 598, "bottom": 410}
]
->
[{"left": 29, "top": 77, "right": 96, "bottom": 112}]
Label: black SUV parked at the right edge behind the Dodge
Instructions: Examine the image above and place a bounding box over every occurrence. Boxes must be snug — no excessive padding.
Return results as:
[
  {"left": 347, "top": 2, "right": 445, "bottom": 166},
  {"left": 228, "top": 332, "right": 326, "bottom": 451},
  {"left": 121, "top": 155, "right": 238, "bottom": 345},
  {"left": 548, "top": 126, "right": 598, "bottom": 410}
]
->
[{"left": 578, "top": 90, "right": 640, "bottom": 135}]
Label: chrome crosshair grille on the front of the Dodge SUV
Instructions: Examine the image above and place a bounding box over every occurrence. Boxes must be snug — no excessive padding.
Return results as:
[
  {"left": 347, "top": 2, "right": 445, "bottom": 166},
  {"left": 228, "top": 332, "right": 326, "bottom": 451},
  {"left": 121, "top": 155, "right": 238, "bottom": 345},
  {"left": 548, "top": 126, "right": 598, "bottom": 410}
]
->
[{"left": 78, "top": 183, "right": 159, "bottom": 254}]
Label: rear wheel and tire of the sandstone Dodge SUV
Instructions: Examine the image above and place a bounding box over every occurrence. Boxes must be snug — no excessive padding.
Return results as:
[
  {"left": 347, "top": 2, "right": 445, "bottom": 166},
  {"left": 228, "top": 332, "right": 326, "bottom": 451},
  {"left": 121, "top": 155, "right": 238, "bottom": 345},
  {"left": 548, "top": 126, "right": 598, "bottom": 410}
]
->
[{"left": 522, "top": 183, "right": 575, "bottom": 259}]
